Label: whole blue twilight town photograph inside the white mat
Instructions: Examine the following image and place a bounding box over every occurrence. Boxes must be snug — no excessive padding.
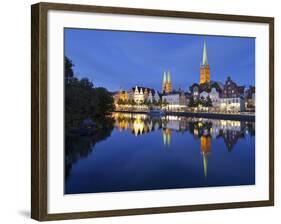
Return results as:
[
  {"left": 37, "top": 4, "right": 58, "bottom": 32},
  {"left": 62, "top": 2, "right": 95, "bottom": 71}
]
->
[{"left": 64, "top": 28, "right": 255, "bottom": 194}]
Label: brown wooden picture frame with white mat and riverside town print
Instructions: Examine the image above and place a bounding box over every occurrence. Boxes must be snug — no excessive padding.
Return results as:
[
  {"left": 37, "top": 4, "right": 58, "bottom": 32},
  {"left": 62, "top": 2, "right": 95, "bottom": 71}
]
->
[{"left": 31, "top": 3, "right": 274, "bottom": 221}]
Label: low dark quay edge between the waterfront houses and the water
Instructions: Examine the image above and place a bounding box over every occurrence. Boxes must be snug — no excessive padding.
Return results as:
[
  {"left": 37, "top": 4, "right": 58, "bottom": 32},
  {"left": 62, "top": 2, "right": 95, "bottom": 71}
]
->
[{"left": 115, "top": 110, "right": 255, "bottom": 122}]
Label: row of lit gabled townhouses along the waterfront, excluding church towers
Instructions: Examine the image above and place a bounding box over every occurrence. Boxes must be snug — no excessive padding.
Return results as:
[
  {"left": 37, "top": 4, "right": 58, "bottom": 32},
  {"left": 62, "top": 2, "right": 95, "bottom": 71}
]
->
[{"left": 114, "top": 77, "right": 255, "bottom": 112}]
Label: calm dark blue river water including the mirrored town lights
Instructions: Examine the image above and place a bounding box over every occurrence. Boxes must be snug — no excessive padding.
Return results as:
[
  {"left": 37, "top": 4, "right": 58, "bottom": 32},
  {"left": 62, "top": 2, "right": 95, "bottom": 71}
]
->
[{"left": 65, "top": 113, "right": 255, "bottom": 194}]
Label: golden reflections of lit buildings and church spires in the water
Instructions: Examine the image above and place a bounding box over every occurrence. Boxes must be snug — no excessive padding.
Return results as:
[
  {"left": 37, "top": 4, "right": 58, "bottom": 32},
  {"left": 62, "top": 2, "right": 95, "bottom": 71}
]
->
[{"left": 113, "top": 113, "right": 255, "bottom": 177}]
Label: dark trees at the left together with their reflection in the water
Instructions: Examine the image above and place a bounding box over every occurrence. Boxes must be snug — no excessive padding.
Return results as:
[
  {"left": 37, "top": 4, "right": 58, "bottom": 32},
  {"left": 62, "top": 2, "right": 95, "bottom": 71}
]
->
[{"left": 64, "top": 57, "right": 114, "bottom": 180}]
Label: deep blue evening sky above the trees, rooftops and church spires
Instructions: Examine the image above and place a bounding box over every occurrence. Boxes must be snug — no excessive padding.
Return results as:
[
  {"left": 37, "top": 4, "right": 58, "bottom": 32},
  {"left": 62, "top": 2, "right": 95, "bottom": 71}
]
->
[{"left": 65, "top": 29, "right": 255, "bottom": 91}]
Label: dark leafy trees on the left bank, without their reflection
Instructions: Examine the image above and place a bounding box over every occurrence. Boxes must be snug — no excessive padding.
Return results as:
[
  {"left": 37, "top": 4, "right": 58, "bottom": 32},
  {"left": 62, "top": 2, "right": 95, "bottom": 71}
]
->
[{"left": 64, "top": 57, "right": 114, "bottom": 128}]
